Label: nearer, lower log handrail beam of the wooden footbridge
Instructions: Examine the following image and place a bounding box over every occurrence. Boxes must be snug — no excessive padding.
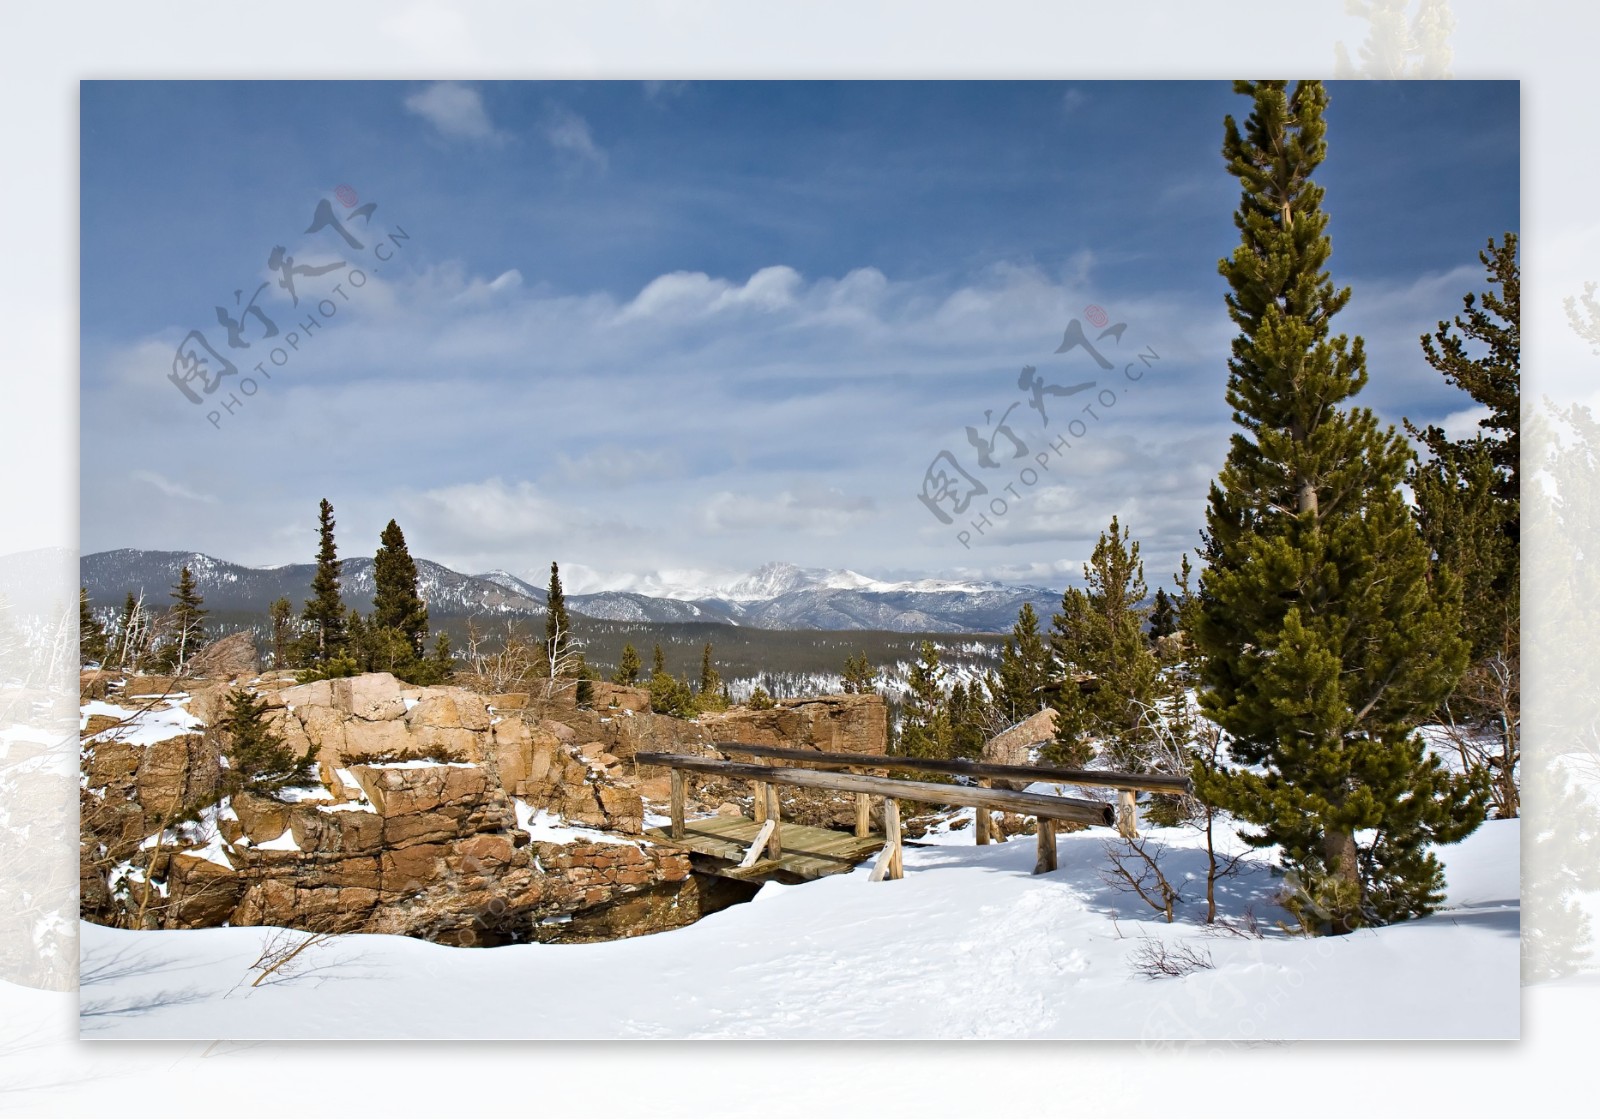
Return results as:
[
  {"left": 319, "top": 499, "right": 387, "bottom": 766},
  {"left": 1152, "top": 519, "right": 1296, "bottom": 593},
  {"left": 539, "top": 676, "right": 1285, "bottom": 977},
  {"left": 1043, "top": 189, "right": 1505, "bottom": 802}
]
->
[{"left": 634, "top": 750, "right": 1117, "bottom": 826}]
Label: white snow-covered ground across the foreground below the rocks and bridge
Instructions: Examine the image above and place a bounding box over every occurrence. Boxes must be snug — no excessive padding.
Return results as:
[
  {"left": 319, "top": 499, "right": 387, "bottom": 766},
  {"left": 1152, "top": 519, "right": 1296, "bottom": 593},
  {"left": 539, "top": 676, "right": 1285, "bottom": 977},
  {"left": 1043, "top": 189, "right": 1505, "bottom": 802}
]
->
[{"left": 80, "top": 821, "right": 1518, "bottom": 1042}]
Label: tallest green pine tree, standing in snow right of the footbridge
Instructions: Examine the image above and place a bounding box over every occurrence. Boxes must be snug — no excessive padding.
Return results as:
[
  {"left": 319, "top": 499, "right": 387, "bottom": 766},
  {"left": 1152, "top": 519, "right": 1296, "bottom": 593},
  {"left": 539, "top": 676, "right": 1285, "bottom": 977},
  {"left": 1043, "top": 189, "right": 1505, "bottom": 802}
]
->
[{"left": 1197, "top": 82, "right": 1483, "bottom": 933}]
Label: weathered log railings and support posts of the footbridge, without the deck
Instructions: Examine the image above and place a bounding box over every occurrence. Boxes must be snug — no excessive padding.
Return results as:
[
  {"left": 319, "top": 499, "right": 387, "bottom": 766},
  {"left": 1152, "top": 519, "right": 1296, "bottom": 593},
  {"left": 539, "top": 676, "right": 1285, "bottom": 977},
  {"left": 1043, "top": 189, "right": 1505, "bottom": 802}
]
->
[{"left": 634, "top": 742, "right": 1189, "bottom": 878}]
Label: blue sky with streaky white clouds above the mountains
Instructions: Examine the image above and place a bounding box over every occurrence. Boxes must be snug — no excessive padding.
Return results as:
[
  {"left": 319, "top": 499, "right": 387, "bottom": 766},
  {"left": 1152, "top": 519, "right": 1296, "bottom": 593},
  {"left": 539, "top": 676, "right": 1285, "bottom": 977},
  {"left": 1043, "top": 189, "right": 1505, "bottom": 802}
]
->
[{"left": 82, "top": 82, "right": 1520, "bottom": 589}]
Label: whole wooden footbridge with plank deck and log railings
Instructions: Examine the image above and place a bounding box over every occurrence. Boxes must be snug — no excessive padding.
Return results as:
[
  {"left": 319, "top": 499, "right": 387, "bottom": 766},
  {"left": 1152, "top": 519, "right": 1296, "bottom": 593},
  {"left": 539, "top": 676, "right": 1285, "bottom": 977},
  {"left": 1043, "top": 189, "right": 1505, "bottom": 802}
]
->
[{"left": 635, "top": 742, "right": 1190, "bottom": 882}]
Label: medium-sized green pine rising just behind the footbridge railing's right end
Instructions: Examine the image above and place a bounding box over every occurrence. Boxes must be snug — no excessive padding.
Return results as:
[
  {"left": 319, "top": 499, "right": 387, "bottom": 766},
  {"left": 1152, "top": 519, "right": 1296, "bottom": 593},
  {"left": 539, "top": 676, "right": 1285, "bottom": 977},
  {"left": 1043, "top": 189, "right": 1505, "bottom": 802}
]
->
[{"left": 1046, "top": 517, "right": 1157, "bottom": 771}]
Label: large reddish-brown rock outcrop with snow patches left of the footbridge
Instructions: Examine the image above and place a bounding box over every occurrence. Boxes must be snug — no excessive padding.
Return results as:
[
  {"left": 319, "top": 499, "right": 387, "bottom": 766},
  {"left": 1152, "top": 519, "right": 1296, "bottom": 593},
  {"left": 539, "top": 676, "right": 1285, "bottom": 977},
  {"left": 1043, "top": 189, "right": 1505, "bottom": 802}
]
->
[{"left": 83, "top": 674, "right": 886, "bottom": 944}]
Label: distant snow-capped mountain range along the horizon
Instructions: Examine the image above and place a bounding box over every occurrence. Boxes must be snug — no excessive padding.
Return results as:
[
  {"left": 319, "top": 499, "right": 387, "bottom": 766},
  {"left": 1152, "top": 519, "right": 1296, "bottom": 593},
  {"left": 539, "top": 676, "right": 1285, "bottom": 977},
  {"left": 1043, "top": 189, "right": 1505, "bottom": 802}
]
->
[{"left": 78, "top": 549, "right": 1061, "bottom": 634}]
